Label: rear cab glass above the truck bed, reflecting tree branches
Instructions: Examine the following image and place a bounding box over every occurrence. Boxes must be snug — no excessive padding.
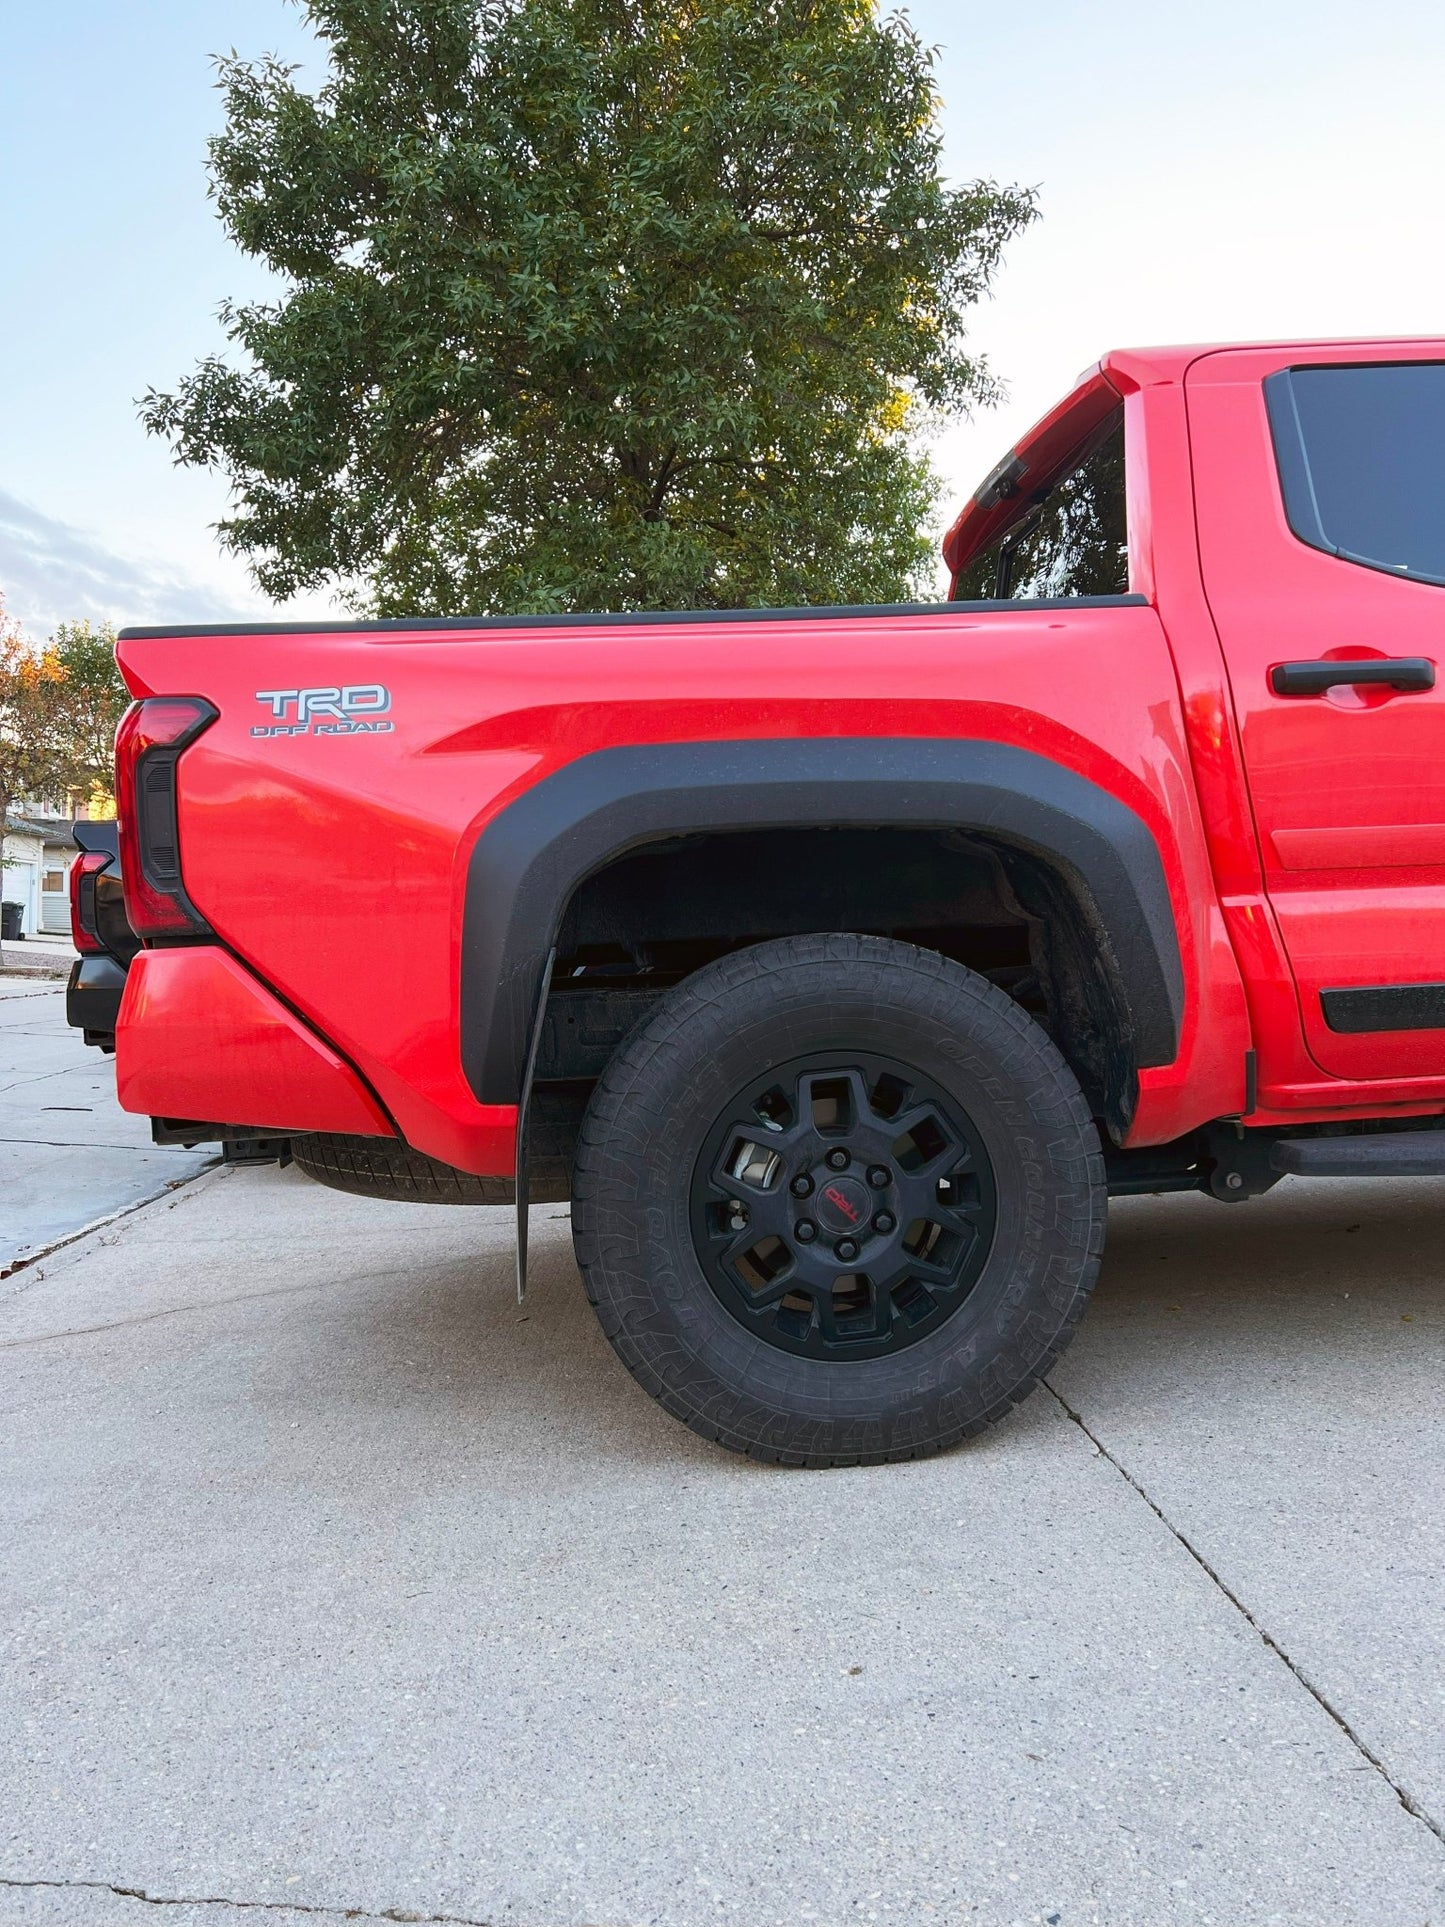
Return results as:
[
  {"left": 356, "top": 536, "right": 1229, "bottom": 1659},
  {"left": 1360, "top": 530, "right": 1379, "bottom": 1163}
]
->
[{"left": 954, "top": 409, "right": 1129, "bottom": 601}]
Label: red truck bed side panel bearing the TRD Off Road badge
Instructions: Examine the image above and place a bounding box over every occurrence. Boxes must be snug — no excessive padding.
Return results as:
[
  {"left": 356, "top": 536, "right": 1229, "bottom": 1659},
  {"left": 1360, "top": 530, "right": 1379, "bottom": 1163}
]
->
[{"left": 123, "top": 607, "right": 1245, "bottom": 1170}]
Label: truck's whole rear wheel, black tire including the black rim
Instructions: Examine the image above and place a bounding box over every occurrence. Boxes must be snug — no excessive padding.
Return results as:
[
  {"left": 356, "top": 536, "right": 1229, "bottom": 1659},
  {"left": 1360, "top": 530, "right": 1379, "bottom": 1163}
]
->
[{"left": 572, "top": 935, "right": 1106, "bottom": 1466}]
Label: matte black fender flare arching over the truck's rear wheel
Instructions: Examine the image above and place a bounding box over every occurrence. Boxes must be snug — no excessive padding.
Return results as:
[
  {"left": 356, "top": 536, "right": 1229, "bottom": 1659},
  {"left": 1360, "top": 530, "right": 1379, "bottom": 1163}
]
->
[{"left": 460, "top": 736, "right": 1183, "bottom": 1104}]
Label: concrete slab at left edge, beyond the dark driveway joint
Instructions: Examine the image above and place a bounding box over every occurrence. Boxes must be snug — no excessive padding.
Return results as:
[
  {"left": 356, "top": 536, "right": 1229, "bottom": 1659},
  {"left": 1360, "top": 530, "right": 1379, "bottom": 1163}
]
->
[{"left": 0, "top": 986, "right": 216, "bottom": 1278}]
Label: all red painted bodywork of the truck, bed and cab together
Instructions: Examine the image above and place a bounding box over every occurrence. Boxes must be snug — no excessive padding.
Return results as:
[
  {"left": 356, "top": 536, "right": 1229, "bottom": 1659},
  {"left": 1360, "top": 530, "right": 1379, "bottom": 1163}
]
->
[{"left": 118, "top": 341, "right": 1445, "bottom": 1174}]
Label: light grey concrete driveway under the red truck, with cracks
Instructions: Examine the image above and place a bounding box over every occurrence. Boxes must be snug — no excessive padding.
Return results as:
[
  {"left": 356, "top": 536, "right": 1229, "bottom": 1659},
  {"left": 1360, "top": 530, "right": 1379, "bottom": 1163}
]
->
[{"left": 0, "top": 986, "right": 1445, "bottom": 1927}]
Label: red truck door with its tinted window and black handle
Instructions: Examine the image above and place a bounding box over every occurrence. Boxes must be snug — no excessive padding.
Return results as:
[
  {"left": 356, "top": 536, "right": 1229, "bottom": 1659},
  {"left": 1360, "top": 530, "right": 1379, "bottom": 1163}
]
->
[{"left": 1185, "top": 341, "right": 1445, "bottom": 1079}]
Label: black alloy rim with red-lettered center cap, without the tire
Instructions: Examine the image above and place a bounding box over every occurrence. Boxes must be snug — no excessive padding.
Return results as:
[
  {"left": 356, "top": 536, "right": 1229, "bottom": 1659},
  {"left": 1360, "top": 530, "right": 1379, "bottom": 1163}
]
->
[{"left": 692, "top": 1052, "right": 996, "bottom": 1360}]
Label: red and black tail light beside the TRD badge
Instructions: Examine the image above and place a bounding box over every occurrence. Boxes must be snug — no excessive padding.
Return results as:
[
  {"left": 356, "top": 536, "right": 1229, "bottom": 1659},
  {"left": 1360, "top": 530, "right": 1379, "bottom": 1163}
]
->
[{"left": 116, "top": 696, "right": 220, "bottom": 937}]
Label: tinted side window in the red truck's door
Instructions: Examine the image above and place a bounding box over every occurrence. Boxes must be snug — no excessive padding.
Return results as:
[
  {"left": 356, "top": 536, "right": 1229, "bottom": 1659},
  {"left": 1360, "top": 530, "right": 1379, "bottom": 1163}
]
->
[{"left": 1264, "top": 362, "right": 1445, "bottom": 584}]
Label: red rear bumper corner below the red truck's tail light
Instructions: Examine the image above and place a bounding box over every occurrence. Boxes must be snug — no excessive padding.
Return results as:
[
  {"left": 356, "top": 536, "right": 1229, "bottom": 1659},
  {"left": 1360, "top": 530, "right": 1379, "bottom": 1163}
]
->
[{"left": 115, "top": 944, "right": 395, "bottom": 1137}]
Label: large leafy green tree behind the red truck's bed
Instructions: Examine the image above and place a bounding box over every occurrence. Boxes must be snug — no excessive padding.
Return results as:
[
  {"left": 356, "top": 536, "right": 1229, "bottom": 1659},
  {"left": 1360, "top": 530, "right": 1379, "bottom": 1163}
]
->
[{"left": 143, "top": 0, "right": 1035, "bottom": 615}]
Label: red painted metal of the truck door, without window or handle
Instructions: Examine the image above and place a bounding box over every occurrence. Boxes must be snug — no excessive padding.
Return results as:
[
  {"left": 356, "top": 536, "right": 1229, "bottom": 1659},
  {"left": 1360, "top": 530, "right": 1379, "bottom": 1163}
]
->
[{"left": 1185, "top": 341, "right": 1445, "bottom": 1083}]
